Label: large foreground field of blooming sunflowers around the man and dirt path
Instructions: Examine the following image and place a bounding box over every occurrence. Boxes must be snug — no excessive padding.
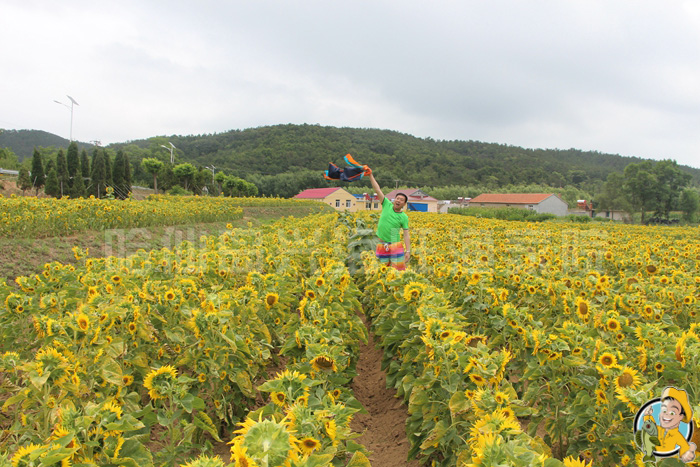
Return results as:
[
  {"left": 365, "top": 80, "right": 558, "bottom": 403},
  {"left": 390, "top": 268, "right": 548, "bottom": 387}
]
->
[{"left": 0, "top": 208, "right": 700, "bottom": 467}]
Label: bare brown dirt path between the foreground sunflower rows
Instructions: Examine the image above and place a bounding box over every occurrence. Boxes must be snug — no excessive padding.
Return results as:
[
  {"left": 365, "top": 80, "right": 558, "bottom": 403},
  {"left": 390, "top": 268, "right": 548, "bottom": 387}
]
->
[{"left": 351, "top": 316, "right": 421, "bottom": 467}]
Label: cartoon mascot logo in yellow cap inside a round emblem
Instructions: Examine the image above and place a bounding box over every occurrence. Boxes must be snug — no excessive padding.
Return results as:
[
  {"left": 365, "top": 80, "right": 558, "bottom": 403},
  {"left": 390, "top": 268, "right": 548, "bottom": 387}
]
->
[{"left": 634, "top": 386, "right": 697, "bottom": 463}]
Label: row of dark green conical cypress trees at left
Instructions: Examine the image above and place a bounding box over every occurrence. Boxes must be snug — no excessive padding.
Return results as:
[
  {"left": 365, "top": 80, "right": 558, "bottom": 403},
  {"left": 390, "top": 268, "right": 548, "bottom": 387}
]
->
[{"left": 18, "top": 141, "right": 132, "bottom": 199}]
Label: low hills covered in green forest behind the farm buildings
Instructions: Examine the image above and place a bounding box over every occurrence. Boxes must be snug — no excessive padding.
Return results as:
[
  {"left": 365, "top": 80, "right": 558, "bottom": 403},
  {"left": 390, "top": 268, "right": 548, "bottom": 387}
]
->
[{"left": 0, "top": 124, "right": 700, "bottom": 193}]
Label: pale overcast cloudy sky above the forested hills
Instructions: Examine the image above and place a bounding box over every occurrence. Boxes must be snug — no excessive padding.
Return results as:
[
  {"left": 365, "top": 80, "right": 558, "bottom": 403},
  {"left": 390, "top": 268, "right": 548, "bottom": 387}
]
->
[{"left": 0, "top": 0, "right": 700, "bottom": 167}]
